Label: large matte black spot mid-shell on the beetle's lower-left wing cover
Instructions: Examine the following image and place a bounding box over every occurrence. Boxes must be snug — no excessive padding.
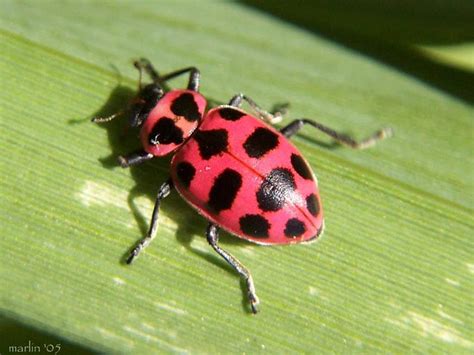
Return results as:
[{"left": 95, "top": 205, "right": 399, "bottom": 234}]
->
[{"left": 208, "top": 169, "right": 242, "bottom": 213}]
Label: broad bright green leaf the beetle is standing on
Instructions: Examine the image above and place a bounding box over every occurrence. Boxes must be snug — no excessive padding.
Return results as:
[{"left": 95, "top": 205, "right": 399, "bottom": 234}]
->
[{"left": 0, "top": 1, "right": 474, "bottom": 353}]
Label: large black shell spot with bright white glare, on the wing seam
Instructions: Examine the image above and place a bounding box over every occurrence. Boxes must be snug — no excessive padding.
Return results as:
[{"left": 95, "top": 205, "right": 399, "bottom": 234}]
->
[{"left": 257, "top": 168, "right": 295, "bottom": 211}]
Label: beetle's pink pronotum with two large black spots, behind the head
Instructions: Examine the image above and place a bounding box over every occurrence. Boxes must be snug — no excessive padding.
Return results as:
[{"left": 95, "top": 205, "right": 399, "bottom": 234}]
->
[{"left": 140, "top": 90, "right": 206, "bottom": 156}]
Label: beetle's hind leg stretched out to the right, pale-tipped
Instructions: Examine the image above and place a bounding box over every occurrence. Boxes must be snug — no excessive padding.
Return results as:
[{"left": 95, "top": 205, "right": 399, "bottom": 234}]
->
[{"left": 280, "top": 118, "right": 393, "bottom": 149}]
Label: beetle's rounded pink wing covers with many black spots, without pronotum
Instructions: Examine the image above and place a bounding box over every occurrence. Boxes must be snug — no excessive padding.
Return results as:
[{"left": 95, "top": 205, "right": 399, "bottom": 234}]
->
[{"left": 171, "top": 106, "right": 323, "bottom": 244}]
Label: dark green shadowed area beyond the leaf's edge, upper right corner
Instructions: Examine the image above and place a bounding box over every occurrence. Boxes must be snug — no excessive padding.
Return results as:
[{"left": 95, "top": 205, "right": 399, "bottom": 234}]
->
[{"left": 241, "top": 0, "right": 474, "bottom": 103}]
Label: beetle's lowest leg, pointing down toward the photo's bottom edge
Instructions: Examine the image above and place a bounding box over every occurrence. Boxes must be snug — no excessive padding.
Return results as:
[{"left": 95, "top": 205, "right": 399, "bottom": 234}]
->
[{"left": 206, "top": 223, "right": 259, "bottom": 313}]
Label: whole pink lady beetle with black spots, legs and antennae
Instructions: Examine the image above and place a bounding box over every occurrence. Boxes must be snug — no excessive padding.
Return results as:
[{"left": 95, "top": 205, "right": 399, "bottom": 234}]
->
[{"left": 94, "top": 59, "right": 391, "bottom": 313}]
